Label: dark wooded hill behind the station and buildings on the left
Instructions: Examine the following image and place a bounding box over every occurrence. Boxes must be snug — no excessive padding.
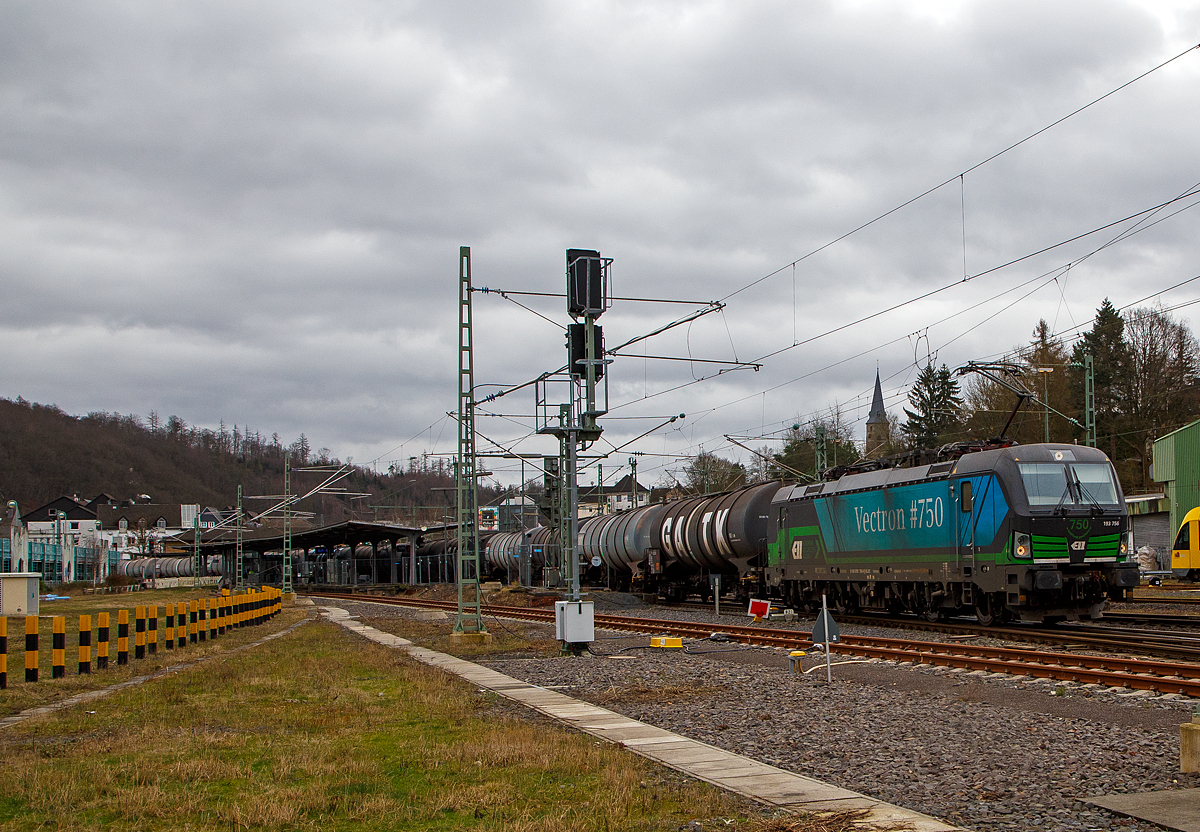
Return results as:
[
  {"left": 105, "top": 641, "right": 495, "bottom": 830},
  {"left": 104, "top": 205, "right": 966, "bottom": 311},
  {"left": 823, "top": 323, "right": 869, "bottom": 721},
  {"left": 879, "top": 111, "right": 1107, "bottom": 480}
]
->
[{"left": 0, "top": 397, "right": 485, "bottom": 525}]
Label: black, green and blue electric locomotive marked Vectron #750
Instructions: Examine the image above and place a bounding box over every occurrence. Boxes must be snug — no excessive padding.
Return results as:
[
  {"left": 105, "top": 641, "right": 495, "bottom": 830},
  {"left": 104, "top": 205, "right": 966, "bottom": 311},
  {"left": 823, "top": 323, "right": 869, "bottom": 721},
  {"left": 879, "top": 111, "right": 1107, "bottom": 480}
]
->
[{"left": 763, "top": 444, "right": 1139, "bottom": 624}]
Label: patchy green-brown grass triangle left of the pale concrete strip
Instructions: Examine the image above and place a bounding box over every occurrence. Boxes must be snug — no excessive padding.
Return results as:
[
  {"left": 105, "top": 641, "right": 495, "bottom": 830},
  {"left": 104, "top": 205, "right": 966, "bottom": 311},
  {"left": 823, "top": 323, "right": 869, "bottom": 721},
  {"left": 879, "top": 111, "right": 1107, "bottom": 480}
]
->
[{"left": 0, "top": 612, "right": 768, "bottom": 832}]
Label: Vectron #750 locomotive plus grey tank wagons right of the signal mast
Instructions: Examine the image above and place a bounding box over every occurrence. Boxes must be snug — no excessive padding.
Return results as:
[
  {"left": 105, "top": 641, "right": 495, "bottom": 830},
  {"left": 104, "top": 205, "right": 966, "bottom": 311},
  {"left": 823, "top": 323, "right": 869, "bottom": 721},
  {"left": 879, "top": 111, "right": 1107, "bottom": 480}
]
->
[{"left": 578, "top": 444, "right": 1139, "bottom": 624}]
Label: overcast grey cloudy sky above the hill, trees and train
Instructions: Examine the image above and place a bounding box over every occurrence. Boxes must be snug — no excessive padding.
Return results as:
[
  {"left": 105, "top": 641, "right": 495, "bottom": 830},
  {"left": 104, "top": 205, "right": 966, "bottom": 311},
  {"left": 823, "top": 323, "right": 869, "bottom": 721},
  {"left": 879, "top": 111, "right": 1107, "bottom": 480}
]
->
[{"left": 0, "top": 0, "right": 1200, "bottom": 484}]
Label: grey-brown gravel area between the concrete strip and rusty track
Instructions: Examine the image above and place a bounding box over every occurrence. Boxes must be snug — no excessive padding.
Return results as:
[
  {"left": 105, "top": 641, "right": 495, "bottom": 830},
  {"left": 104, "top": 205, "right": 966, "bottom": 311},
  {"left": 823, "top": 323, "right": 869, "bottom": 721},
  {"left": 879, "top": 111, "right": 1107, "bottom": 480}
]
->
[{"left": 340, "top": 603, "right": 1200, "bottom": 832}]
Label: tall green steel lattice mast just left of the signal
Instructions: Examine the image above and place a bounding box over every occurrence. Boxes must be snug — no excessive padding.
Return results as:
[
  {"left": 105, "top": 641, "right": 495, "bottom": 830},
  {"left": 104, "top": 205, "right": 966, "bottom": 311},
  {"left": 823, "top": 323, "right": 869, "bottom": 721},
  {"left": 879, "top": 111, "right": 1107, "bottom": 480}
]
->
[{"left": 451, "top": 246, "right": 492, "bottom": 641}]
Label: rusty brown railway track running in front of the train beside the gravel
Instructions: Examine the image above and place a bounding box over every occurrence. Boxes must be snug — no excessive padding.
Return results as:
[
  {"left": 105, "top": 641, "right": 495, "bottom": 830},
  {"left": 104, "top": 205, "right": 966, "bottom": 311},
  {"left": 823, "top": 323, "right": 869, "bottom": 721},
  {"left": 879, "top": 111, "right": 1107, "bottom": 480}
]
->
[{"left": 304, "top": 593, "right": 1200, "bottom": 698}]
